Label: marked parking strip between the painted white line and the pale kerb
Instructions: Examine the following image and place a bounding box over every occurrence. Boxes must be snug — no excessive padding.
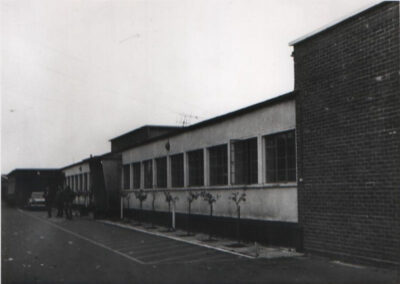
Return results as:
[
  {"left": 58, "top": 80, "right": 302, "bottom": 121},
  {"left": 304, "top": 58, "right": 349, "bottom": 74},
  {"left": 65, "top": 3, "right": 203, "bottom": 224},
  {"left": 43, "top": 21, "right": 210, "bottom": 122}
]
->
[{"left": 21, "top": 211, "right": 242, "bottom": 265}]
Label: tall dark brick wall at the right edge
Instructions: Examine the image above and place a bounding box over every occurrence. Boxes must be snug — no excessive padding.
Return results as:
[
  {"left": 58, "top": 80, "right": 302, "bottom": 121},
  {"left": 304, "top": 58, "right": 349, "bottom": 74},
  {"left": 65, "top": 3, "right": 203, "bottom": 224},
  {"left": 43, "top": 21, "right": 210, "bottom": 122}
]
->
[{"left": 293, "top": 2, "right": 400, "bottom": 263}]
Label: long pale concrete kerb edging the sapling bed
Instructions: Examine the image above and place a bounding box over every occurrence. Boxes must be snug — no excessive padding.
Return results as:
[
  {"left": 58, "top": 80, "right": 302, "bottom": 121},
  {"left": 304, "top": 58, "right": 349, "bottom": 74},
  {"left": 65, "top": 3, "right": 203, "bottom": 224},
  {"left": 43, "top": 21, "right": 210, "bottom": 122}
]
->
[{"left": 97, "top": 220, "right": 256, "bottom": 259}]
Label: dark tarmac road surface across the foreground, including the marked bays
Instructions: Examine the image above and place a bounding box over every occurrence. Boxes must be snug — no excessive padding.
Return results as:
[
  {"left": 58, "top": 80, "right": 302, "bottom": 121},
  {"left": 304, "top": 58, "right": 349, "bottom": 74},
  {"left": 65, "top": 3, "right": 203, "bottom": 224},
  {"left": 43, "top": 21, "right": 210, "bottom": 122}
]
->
[{"left": 2, "top": 204, "right": 400, "bottom": 283}]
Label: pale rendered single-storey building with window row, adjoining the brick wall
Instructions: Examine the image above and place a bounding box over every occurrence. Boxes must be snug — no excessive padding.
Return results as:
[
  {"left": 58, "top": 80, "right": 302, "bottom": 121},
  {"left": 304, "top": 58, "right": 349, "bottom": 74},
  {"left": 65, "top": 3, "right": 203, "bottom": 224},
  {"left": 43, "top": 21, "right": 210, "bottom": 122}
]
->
[{"left": 117, "top": 93, "right": 299, "bottom": 246}]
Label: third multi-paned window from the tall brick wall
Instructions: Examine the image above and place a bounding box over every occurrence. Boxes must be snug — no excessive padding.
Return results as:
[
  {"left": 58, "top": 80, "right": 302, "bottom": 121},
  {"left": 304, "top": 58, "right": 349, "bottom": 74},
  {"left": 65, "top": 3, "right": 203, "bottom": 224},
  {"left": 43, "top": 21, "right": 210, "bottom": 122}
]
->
[{"left": 208, "top": 145, "right": 228, "bottom": 185}]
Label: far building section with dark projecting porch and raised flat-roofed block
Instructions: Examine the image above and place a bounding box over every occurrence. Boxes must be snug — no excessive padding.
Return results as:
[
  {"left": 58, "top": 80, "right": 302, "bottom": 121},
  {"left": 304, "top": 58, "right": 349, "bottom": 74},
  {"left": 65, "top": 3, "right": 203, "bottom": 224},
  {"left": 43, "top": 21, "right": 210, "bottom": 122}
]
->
[{"left": 61, "top": 125, "right": 180, "bottom": 215}]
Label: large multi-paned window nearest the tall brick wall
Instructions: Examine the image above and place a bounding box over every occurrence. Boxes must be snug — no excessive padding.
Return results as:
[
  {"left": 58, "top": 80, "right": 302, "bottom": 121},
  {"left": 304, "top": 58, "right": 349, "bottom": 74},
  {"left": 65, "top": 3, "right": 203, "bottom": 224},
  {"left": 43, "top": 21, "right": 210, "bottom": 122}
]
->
[{"left": 265, "top": 130, "right": 296, "bottom": 182}]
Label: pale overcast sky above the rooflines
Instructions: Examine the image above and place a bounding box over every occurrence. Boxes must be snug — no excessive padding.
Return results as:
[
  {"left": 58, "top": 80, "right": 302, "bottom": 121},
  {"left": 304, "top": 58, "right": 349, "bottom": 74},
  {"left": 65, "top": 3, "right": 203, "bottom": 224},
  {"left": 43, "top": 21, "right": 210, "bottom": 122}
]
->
[{"left": 1, "top": 0, "right": 376, "bottom": 173}]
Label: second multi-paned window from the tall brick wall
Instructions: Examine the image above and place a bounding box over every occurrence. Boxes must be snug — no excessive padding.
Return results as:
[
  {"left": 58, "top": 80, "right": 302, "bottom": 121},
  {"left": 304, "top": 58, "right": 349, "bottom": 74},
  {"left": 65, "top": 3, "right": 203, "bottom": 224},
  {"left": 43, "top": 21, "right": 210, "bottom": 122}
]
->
[{"left": 231, "top": 138, "right": 258, "bottom": 184}]
